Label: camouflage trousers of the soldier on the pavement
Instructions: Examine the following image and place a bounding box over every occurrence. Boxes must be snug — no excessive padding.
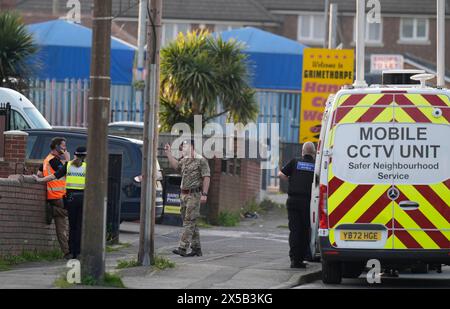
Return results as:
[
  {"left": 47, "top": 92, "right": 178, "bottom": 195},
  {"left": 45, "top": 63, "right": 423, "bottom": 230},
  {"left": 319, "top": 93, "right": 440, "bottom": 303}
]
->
[{"left": 179, "top": 193, "right": 201, "bottom": 250}]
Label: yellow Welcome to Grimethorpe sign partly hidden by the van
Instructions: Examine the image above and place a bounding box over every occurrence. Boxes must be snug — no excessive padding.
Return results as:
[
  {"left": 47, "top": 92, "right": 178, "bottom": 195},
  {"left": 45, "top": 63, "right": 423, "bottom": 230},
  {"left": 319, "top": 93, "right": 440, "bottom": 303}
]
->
[{"left": 299, "top": 48, "right": 354, "bottom": 144}]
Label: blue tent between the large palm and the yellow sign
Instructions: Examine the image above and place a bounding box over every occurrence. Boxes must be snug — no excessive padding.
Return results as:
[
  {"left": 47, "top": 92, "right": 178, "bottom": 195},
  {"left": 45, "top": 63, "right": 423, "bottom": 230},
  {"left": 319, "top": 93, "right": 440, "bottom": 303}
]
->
[{"left": 214, "top": 27, "right": 306, "bottom": 90}]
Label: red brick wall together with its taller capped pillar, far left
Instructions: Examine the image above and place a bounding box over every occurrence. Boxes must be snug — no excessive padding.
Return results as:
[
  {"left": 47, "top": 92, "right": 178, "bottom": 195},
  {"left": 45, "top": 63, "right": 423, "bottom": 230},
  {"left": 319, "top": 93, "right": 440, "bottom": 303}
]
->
[{"left": 0, "top": 131, "right": 56, "bottom": 256}]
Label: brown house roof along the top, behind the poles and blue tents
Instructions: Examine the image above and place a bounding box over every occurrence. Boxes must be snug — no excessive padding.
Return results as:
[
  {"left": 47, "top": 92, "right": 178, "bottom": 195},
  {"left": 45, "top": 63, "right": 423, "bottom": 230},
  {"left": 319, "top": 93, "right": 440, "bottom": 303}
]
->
[{"left": 16, "top": 0, "right": 278, "bottom": 23}]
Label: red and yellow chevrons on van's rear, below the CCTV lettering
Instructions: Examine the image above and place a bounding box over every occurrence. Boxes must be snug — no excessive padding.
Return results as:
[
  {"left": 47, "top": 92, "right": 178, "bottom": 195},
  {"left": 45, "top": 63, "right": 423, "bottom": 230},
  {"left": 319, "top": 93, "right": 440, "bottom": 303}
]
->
[{"left": 328, "top": 177, "right": 450, "bottom": 249}]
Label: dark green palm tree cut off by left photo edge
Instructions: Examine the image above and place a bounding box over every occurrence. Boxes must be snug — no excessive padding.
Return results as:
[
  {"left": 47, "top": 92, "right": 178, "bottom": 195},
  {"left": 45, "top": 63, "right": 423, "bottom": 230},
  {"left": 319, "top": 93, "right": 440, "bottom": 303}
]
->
[{"left": 0, "top": 11, "right": 38, "bottom": 89}]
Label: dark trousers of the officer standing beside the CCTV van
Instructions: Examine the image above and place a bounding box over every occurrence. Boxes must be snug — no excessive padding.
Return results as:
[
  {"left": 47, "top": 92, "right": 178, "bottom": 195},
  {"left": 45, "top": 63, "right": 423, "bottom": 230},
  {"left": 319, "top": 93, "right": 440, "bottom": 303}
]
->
[{"left": 287, "top": 196, "right": 310, "bottom": 262}]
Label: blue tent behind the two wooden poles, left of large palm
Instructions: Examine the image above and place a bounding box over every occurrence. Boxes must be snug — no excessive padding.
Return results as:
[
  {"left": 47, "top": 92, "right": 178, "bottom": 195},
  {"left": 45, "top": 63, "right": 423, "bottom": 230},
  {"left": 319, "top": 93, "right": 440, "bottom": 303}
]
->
[{"left": 27, "top": 20, "right": 136, "bottom": 85}]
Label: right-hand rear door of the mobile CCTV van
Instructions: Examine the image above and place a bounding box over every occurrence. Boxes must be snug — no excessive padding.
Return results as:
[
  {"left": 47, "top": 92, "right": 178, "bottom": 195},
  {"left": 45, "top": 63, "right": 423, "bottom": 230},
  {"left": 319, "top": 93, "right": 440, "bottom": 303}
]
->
[{"left": 394, "top": 94, "right": 450, "bottom": 249}]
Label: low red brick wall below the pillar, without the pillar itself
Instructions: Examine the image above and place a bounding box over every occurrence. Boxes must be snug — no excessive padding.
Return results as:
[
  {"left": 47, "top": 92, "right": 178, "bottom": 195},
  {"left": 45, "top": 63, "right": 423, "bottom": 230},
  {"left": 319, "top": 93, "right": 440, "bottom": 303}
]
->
[{"left": 0, "top": 175, "right": 58, "bottom": 256}]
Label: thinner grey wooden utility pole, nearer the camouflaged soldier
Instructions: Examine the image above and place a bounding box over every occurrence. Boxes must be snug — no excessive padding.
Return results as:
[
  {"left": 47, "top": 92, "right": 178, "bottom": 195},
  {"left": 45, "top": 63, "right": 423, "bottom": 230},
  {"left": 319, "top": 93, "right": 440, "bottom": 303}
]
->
[{"left": 138, "top": 0, "right": 162, "bottom": 266}]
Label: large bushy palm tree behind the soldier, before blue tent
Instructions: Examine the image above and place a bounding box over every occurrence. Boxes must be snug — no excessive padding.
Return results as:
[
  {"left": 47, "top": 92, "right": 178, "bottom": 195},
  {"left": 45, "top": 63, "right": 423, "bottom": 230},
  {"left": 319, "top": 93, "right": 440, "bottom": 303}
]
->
[{"left": 160, "top": 31, "right": 258, "bottom": 131}]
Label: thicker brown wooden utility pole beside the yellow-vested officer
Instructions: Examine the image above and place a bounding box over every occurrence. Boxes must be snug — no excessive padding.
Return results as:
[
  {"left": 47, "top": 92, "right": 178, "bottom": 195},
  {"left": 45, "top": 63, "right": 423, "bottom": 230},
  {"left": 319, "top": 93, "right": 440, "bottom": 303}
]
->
[{"left": 81, "top": 0, "right": 112, "bottom": 281}]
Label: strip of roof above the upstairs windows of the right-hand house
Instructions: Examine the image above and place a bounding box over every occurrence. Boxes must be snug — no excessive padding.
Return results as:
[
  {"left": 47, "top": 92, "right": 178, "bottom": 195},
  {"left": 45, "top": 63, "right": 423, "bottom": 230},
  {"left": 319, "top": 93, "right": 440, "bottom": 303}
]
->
[{"left": 256, "top": 0, "right": 450, "bottom": 15}]
